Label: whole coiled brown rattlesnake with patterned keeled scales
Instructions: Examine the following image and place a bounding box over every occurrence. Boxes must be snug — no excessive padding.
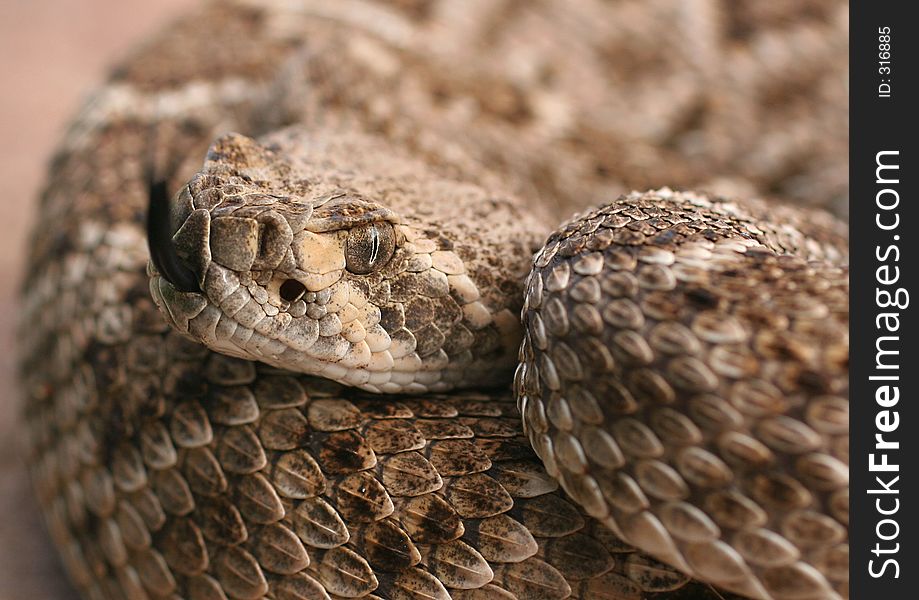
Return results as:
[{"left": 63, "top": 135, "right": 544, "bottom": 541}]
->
[{"left": 20, "top": 0, "right": 848, "bottom": 600}]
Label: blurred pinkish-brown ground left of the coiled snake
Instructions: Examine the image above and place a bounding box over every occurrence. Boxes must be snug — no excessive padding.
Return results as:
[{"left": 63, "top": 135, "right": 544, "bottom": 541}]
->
[{"left": 0, "top": 0, "right": 189, "bottom": 600}]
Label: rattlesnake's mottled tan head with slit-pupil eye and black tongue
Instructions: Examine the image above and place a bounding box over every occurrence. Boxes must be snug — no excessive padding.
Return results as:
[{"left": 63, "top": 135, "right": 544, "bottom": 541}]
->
[{"left": 150, "top": 134, "right": 538, "bottom": 393}]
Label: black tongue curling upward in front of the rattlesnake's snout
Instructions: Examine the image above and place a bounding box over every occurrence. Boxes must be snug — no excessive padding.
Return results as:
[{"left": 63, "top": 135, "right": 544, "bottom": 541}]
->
[{"left": 147, "top": 177, "right": 201, "bottom": 293}]
